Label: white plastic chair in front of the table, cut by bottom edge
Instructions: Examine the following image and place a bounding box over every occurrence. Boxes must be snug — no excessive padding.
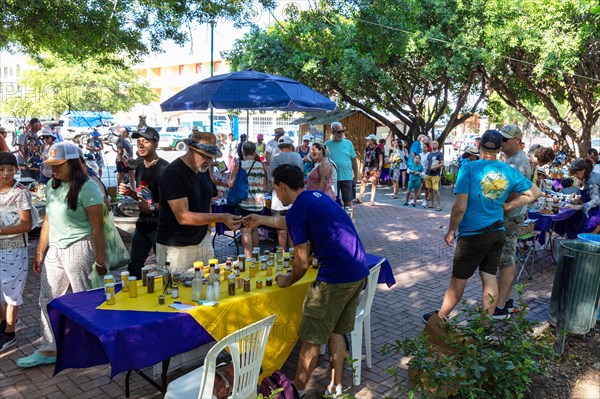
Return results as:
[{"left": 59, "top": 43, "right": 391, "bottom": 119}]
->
[{"left": 165, "top": 315, "right": 275, "bottom": 399}]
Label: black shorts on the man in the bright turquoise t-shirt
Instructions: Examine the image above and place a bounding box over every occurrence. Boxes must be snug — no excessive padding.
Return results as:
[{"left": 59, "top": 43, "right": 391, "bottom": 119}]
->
[{"left": 452, "top": 230, "right": 506, "bottom": 280}]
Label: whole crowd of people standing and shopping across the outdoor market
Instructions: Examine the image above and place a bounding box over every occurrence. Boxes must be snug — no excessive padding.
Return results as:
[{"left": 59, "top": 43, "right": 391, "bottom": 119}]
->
[{"left": 0, "top": 118, "right": 600, "bottom": 393}]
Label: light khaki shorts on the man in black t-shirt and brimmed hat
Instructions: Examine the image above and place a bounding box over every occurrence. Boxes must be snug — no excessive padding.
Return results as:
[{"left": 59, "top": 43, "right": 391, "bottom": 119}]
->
[{"left": 156, "top": 233, "right": 215, "bottom": 273}]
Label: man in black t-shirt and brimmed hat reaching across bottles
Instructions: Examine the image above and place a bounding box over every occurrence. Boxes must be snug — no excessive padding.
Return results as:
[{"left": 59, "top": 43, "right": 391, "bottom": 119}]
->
[{"left": 156, "top": 131, "right": 241, "bottom": 272}]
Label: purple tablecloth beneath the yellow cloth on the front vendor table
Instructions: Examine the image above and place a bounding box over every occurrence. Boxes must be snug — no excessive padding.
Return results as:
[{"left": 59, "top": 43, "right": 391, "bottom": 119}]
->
[{"left": 48, "top": 254, "right": 396, "bottom": 378}]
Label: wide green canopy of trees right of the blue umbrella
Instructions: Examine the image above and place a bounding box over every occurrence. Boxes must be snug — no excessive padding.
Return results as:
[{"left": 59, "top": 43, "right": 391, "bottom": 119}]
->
[{"left": 226, "top": 0, "right": 600, "bottom": 154}]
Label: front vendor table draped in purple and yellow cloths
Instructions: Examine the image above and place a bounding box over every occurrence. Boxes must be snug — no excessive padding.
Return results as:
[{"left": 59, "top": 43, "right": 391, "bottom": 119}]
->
[{"left": 48, "top": 255, "right": 395, "bottom": 393}]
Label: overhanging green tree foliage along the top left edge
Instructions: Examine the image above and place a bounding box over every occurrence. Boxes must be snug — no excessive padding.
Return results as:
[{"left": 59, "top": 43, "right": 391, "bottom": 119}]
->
[{"left": 0, "top": 0, "right": 273, "bottom": 60}]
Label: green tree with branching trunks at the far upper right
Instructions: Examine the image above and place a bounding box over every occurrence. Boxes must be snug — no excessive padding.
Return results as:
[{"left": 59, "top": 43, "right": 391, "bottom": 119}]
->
[{"left": 472, "top": 0, "right": 600, "bottom": 156}]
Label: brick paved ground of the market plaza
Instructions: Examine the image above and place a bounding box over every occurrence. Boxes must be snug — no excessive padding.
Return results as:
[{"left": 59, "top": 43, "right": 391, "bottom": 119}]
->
[{"left": 0, "top": 187, "right": 554, "bottom": 399}]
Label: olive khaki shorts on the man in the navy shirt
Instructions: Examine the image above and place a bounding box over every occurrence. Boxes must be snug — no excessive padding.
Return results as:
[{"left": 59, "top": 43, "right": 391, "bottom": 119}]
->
[{"left": 298, "top": 278, "right": 367, "bottom": 345}]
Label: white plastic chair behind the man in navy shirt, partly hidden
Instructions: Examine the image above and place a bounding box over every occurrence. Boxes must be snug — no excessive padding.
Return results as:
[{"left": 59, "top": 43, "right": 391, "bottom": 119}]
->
[{"left": 351, "top": 259, "right": 385, "bottom": 385}]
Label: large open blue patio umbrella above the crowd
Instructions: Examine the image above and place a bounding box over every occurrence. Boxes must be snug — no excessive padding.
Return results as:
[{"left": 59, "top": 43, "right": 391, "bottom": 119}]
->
[{"left": 160, "top": 69, "right": 336, "bottom": 112}]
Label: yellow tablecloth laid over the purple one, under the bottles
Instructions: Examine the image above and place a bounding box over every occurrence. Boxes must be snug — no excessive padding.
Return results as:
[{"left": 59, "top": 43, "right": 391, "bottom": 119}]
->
[{"left": 98, "top": 269, "right": 317, "bottom": 376}]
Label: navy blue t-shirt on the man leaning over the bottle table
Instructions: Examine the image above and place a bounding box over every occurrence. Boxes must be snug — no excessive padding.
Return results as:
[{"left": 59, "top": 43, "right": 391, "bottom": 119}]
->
[{"left": 285, "top": 190, "right": 369, "bottom": 284}]
